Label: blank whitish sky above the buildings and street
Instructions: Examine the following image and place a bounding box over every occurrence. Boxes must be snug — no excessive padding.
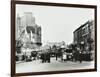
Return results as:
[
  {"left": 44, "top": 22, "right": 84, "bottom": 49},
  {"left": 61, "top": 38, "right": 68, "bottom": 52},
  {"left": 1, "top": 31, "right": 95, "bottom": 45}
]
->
[{"left": 16, "top": 4, "right": 94, "bottom": 44}]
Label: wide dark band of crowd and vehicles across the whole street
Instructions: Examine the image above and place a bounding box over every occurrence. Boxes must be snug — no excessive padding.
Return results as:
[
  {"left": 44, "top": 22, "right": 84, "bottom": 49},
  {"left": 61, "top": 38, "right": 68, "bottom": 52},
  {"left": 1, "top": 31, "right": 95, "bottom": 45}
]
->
[{"left": 15, "top": 44, "right": 93, "bottom": 63}]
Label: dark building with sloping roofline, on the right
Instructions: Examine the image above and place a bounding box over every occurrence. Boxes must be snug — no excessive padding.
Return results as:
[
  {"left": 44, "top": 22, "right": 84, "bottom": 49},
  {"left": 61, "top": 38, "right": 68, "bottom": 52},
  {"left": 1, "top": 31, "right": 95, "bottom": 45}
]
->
[{"left": 73, "top": 20, "right": 95, "bottom": 53}]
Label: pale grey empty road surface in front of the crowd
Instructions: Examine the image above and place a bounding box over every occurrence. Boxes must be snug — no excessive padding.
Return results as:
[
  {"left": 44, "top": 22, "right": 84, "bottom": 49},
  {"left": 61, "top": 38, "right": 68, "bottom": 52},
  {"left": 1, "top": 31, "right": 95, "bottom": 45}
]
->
[{"left": 16, "top": 57, "right": 94, "bottom": 73}]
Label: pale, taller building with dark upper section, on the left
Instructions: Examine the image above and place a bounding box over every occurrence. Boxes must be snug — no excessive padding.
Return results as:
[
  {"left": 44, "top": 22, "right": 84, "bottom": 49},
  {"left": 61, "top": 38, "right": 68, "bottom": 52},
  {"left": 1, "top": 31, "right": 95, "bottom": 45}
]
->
[{"left": 16, "top": 12, "right": 42, "bottom": 49}]
